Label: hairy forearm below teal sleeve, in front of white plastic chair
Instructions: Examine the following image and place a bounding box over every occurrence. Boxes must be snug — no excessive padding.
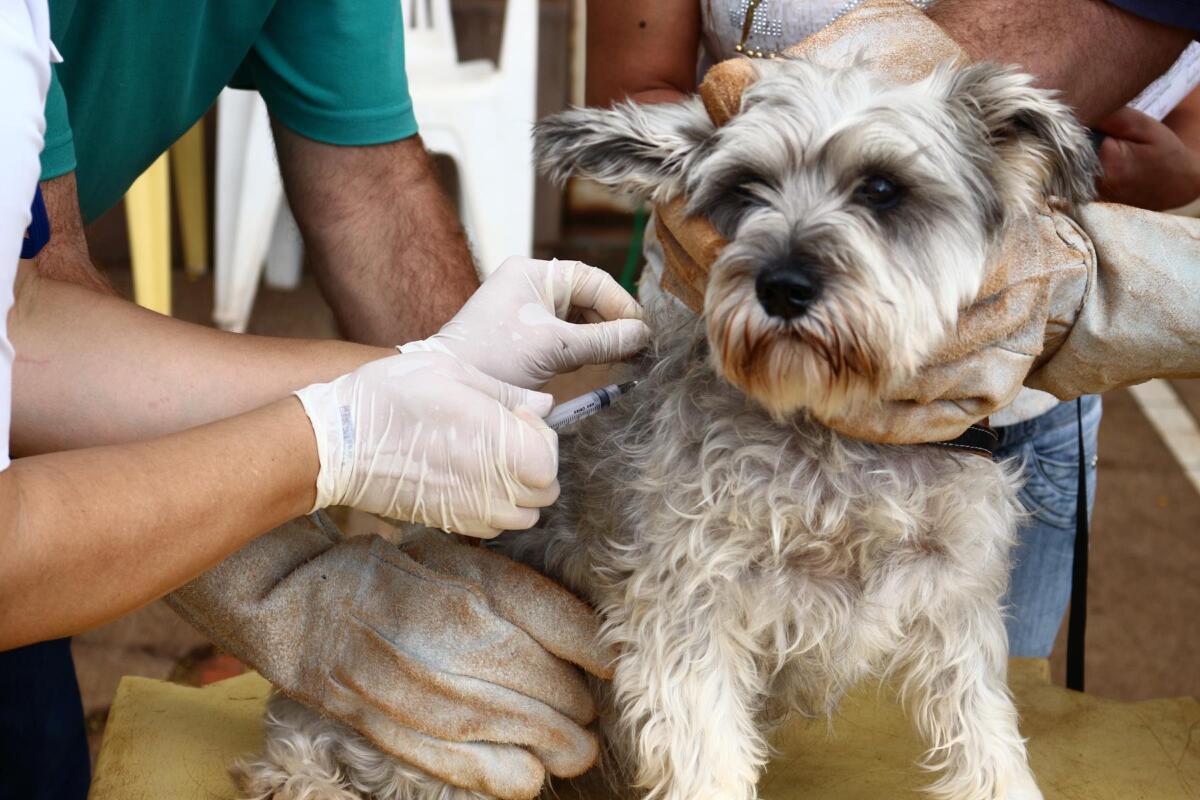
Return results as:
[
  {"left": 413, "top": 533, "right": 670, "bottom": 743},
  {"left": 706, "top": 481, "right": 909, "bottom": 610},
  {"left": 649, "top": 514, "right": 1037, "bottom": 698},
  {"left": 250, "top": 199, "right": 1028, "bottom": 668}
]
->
[{"left": 274, "top": 124, "right": 477, "bottom": 345}]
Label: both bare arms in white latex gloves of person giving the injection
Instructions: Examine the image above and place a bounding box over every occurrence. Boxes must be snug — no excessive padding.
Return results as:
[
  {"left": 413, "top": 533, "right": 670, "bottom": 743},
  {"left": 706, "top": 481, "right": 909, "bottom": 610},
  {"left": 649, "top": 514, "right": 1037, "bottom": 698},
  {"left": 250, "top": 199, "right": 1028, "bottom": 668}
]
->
[{"left": 0, "top": 253, "right": 647, "bottom": 648}]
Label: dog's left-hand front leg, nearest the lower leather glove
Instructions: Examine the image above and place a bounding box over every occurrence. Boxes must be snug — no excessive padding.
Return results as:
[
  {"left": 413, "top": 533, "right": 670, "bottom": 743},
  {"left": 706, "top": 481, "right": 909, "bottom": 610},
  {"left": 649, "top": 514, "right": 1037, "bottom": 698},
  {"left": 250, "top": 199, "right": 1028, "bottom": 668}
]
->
[{"left": 610, "top": 582, "right": 768, "bottom": 800}]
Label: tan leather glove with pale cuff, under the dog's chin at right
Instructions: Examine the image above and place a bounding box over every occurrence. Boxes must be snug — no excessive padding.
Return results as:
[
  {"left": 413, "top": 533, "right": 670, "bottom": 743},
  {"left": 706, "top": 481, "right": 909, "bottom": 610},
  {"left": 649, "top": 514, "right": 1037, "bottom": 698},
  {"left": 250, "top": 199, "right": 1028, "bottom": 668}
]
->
[{"left": 826, "top": 203, "right": 1200, "bottom": 444}]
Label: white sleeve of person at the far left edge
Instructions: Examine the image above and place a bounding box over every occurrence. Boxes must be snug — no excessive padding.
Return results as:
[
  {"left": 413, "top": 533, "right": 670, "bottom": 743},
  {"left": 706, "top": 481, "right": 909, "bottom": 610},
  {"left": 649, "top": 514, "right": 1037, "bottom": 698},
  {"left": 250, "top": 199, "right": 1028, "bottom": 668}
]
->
[{"left": 0, "top": 0, "right": 50, "bottom": 469}]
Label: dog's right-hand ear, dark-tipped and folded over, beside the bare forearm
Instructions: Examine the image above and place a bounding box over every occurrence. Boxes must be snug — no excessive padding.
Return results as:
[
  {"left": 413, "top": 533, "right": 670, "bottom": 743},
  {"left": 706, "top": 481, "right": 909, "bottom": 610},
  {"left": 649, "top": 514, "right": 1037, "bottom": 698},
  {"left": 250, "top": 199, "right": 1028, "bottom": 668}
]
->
[{"left": 947, "top": 62, "right": 1100, "bottom": 209}]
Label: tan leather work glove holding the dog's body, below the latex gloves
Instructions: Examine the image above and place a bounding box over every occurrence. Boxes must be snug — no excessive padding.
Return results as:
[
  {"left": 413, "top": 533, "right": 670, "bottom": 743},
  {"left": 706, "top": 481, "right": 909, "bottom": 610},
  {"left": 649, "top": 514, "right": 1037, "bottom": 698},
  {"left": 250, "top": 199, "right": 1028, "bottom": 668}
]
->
[{"left": 167, "top": 518, "right": 610, "bottom": 800}]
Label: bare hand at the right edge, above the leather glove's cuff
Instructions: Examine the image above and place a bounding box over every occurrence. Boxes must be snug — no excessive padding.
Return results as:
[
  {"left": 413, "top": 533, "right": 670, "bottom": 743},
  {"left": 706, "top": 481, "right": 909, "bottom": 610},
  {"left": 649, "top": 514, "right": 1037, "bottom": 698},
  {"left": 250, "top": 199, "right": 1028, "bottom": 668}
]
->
[{"left": 1096, "top": 107, "right": 1200, "bottom": 211}]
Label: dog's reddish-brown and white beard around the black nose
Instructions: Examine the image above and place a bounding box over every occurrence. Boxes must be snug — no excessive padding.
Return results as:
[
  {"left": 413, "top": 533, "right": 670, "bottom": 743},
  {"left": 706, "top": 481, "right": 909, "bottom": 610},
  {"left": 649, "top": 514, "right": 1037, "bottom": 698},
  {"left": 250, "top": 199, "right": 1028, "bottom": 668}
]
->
[{"left": 706, "top": 224, "right": 986, "bottom": 419}]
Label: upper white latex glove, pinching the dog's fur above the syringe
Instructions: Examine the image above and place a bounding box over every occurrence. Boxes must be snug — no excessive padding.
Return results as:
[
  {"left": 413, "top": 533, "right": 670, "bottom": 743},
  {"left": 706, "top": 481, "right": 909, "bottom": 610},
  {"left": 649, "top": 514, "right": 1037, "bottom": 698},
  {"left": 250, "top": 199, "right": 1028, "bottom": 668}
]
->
[{"left": 400, "top": 257, "right": 649, "bottom": 389}]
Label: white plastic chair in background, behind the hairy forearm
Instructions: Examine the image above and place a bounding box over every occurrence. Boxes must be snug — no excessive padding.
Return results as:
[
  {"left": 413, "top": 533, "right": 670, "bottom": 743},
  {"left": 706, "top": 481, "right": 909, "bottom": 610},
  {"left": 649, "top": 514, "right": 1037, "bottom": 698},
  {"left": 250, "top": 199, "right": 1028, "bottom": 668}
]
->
[{"left": 212, "top": 0, "right": 538, "bottom": 331}]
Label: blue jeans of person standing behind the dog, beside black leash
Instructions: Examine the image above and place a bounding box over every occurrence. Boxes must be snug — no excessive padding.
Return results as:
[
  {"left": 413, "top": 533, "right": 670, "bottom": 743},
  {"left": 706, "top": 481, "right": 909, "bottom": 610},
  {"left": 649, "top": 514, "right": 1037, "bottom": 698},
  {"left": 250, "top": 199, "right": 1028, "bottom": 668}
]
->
[{"left": 996, "top": 396, "right": 1100, "bottom": 658}]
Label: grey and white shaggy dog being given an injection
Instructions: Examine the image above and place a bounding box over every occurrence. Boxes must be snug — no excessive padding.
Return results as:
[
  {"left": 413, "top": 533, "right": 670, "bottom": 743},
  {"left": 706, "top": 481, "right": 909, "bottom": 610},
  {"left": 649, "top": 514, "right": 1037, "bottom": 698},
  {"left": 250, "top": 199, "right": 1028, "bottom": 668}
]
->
[{"left": 240, "top": 59, "right": 1098, "bottom": 800}]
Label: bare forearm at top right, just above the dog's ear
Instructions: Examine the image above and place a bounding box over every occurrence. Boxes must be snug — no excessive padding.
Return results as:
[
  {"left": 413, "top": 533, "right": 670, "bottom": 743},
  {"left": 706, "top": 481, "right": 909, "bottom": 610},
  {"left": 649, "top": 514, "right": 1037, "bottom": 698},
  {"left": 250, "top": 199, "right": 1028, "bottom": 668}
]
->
[{"left": 930, "top": 0, "right": 1192, "bottom": 124}]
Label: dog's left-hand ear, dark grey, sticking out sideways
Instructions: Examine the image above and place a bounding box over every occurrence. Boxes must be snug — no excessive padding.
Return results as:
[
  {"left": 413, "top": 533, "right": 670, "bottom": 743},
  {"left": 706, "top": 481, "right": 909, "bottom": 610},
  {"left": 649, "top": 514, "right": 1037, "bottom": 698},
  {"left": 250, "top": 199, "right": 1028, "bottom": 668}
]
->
[{"left": 534, "top": 97, "right": 715, "bottom": 203}]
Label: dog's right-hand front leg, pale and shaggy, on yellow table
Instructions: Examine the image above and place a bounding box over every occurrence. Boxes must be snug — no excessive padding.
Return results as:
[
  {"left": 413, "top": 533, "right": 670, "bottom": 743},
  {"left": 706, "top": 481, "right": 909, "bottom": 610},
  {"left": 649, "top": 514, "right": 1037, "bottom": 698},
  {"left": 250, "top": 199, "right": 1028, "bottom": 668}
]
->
[{"left": 888, "top": 513, "right": 1042, "bottom": 800}]
